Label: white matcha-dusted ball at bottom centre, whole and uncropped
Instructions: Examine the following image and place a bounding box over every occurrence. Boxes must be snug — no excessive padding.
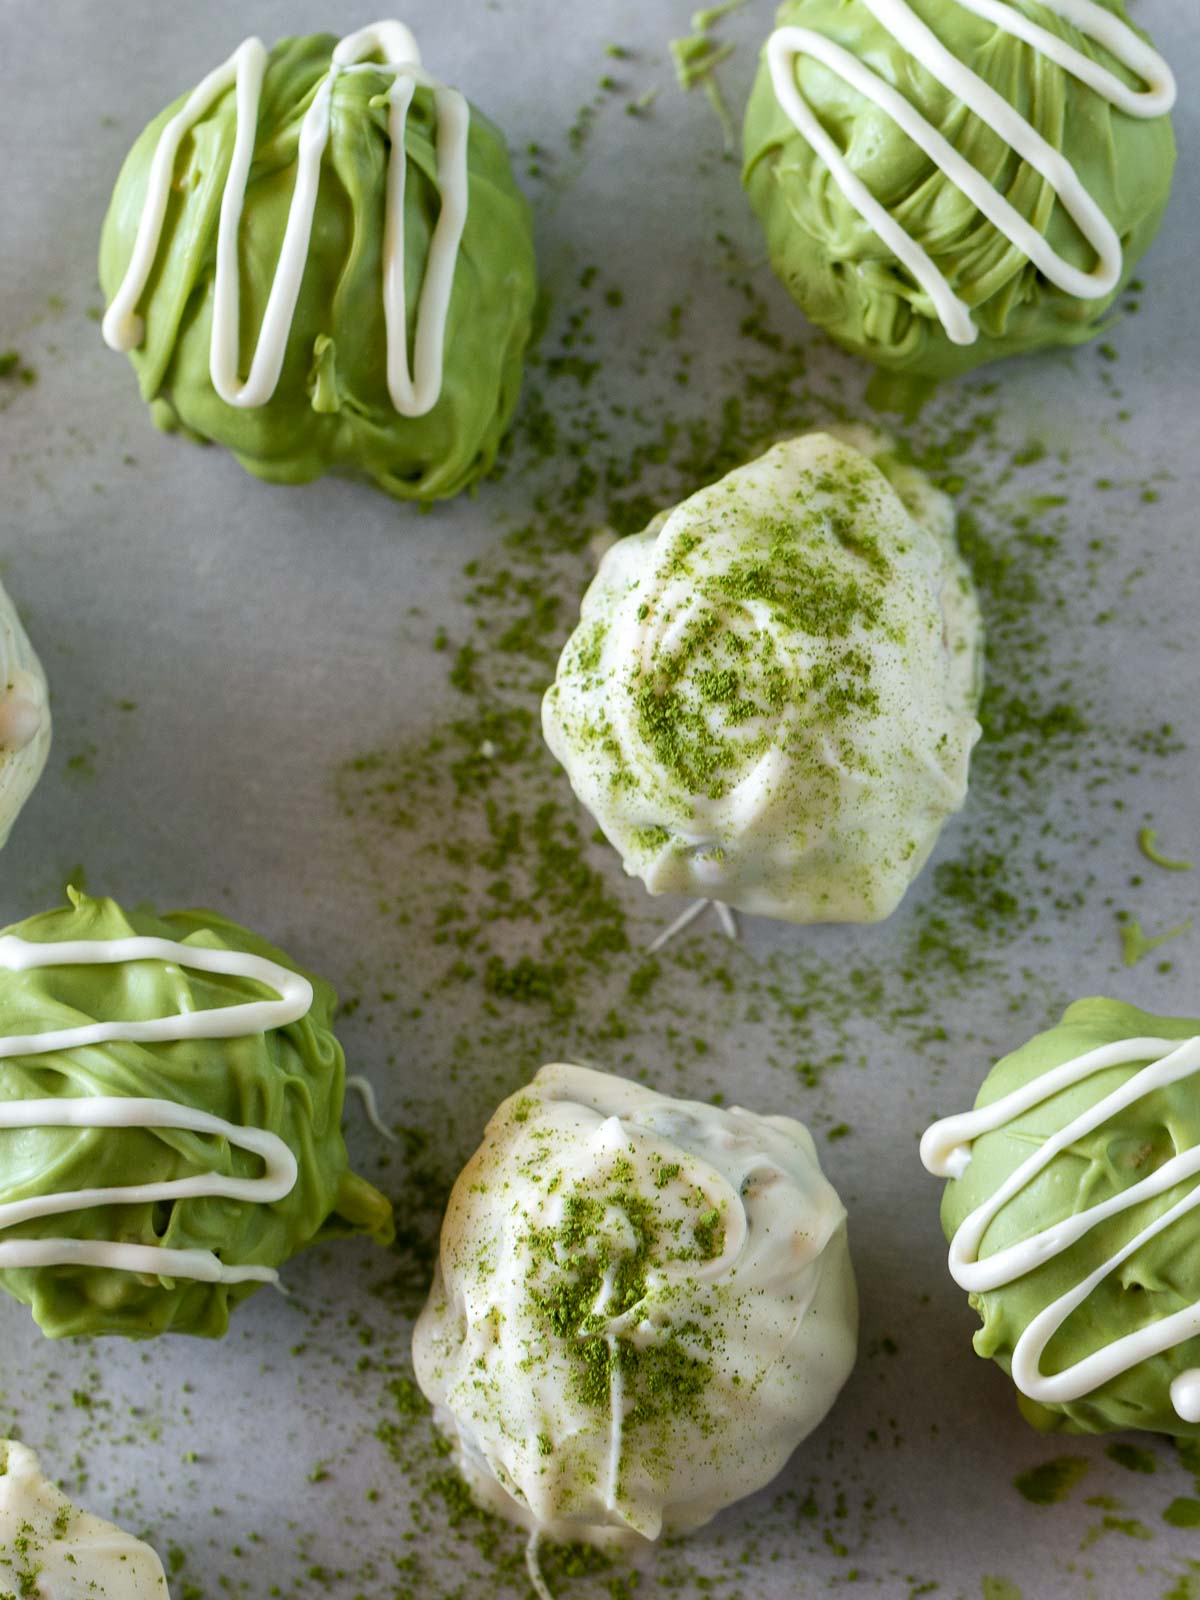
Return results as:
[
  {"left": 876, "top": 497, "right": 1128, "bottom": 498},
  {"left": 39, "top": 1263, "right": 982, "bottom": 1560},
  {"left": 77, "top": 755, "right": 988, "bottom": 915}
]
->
[{"left": 413, "top": 1066, "right": 858, "bottom": 1544}]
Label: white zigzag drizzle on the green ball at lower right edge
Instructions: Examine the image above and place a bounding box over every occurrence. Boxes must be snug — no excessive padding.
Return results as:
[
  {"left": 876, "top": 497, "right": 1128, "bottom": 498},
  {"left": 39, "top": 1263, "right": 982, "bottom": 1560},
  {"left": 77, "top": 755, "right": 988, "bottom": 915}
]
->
[{"left": 920, "top": 1037, "right": 1200, "bottom": 1422}]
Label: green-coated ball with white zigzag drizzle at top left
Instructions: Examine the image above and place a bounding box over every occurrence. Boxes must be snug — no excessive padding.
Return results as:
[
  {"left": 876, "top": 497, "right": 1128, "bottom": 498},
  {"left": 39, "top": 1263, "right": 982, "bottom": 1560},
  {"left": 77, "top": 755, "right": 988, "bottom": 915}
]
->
[{"left": 99, "top": 22, "right": 536, "bottom": 501}]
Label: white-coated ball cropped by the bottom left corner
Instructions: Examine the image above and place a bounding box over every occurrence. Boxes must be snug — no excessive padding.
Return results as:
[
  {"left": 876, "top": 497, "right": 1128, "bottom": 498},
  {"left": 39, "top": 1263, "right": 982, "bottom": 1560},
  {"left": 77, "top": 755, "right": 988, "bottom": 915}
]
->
[{"left": 0, "top": 1440, "right": 170, "bottom": 1600}]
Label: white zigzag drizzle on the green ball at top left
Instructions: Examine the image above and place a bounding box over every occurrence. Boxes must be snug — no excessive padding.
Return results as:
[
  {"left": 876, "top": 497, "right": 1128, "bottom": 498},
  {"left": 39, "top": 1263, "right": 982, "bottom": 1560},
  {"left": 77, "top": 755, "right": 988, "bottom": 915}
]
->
[{"left": 102, "top": 21, "right": 470, "bottom": 416}]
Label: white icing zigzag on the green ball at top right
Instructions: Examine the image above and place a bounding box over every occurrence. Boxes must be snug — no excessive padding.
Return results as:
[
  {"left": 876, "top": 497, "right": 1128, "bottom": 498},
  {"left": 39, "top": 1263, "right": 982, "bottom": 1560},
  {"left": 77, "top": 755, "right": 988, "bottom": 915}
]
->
[{"left": 766, "top": 0, "right": 1176, "bottom": 344}]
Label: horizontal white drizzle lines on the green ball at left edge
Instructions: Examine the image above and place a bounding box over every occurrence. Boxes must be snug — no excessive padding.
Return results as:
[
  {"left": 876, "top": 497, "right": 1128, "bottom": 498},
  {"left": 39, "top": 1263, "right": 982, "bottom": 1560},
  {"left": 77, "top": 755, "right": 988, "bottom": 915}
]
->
[{"left": 0, "top": 934, "right": 312, "bottom": 1283}]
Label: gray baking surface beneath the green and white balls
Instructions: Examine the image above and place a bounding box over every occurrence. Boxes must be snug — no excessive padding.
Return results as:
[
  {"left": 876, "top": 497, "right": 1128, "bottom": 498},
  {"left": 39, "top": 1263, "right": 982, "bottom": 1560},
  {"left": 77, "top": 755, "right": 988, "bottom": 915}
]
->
[{"left": 0, "top": 0, "right": 1200, "bottom": 1600}]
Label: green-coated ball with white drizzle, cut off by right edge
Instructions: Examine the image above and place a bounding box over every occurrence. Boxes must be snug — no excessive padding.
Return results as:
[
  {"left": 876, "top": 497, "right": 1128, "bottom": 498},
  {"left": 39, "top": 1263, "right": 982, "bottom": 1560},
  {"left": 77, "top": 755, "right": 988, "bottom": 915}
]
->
[{"left": 922, "top": 1000, "right": 1200, "bottom": 1435}]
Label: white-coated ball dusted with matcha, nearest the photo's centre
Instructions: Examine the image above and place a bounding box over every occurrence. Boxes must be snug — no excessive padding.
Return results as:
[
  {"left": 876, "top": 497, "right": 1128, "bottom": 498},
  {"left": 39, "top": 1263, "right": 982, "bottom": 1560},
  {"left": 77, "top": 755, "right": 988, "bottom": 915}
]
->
[{"left": 542, "top": 429, "right": 981, "bottom": 922}]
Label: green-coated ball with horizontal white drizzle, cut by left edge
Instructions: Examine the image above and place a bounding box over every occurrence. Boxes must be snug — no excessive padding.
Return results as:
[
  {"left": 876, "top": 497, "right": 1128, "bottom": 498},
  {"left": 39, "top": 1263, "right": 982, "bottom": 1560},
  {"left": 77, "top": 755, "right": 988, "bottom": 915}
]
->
[{"left": 0, "top": 891, "right": 394, "bottom": 1339}]
